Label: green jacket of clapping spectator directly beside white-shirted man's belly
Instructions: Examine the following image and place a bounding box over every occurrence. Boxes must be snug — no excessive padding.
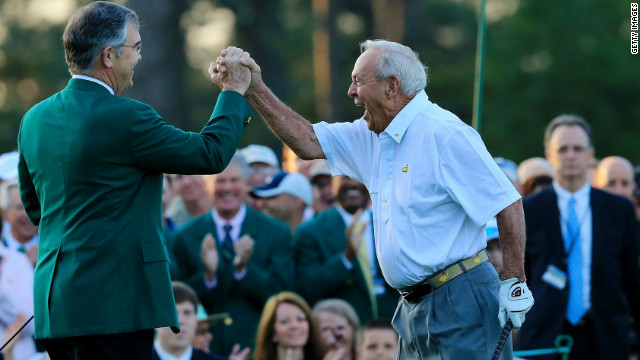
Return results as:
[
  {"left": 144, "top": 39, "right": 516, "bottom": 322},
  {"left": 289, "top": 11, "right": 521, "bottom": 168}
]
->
[{"left": 293, "top": 207, "right": 399, "bottom": 324}]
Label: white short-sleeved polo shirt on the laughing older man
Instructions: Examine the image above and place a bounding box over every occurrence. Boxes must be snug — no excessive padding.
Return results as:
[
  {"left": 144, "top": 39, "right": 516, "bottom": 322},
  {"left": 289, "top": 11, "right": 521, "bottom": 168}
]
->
[{"left": 313, "top": 90, "right": 520, "bottom": 289}]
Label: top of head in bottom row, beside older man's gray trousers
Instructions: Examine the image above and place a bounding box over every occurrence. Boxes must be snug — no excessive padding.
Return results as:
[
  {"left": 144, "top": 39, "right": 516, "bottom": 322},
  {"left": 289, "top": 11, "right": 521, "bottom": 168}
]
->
[{"left": 357, "top": 318, "right": 398, "bottom": 360}]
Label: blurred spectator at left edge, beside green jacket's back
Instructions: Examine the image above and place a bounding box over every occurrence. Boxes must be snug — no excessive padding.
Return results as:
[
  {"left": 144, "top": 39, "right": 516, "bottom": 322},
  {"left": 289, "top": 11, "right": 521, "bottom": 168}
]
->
[{"left": 0, "top": 179, "right": 38, "bottom": 267}]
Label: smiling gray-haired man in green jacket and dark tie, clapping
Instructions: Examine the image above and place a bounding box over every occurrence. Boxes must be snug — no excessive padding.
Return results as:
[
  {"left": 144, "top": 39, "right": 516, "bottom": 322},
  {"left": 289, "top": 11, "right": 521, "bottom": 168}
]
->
[{"left": 175, "top": 152, "right": 293, "bottom": 354}]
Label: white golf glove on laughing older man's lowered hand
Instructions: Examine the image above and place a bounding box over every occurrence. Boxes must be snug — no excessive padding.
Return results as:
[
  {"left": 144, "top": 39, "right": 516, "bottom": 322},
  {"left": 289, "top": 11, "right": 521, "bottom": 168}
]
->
[{"left": 498, "top": 278, "right": 533, "bottom": 329}]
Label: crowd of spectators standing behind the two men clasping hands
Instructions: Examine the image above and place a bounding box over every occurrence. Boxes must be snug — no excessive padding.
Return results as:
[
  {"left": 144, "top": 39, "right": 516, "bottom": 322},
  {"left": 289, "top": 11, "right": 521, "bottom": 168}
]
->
[{"left": 0, "top": 116, "right": 640, "bottom": 360}]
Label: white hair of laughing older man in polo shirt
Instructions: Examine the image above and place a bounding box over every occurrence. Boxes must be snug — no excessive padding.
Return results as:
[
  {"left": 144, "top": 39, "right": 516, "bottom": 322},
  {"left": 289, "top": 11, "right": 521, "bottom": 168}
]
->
[{"left": 360, "top": 40, "right": 428, "bottom": 96}]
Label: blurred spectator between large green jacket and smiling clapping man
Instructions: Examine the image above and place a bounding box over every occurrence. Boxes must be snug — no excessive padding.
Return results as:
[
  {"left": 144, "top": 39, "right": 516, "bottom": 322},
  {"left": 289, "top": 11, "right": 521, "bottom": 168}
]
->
[{"left": 165, "top": 174, "right": 213, "bottom": 227}]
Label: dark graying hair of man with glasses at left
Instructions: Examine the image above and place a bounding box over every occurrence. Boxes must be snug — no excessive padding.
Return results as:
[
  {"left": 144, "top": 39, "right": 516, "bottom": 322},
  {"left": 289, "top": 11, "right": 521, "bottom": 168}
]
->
[{"left": 62, "top": 1, "right": 140, "bottom": 75}]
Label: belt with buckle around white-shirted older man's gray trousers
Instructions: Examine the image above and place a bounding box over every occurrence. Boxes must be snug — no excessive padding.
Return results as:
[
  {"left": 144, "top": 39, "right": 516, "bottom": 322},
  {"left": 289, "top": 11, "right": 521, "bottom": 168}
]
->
[{"left": 398, "top": 249, "right": 489, "bottom": 303}]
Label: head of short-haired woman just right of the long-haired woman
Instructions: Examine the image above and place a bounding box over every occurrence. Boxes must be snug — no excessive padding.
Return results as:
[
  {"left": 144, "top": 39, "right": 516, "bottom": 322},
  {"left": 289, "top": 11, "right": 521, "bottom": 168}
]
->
[{"left": 313, "top": 299, "right": 360, "bottom": 360}]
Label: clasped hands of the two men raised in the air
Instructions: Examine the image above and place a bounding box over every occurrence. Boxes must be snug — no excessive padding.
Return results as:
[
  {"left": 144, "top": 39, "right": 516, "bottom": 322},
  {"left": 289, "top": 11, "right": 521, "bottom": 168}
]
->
[{"left": 209, "top": 46, "right": 251, "bottom": 95}]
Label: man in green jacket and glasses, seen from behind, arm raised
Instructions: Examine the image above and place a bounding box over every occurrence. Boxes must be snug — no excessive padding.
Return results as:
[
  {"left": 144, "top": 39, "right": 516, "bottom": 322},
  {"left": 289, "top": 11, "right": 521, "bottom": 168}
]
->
[{"left": 18, "top": 1, "right": 251, "bottom": 360}]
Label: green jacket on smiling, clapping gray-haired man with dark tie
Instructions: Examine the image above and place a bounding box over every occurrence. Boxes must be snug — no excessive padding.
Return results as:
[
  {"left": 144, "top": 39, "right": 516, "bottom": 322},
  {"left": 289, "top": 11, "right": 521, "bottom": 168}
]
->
[{"left": 175, "top": 207, "right": 293, "bottom": 354}]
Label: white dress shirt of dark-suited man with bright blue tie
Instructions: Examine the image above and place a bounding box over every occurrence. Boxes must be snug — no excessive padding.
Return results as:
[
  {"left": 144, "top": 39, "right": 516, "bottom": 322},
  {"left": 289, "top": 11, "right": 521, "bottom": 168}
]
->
[{"left": 553, "top": 181, "right": 593, "bottom": 309}]
